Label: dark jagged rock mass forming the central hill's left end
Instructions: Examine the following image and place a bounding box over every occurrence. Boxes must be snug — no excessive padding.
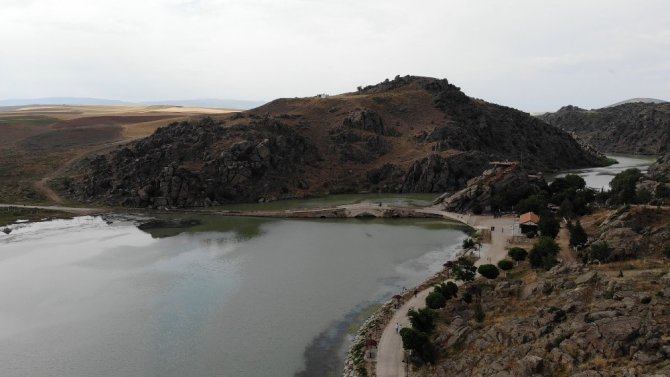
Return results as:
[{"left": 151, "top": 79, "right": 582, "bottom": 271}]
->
[{"left": 67, "top": 118, "right": 319, "bottom": 208}]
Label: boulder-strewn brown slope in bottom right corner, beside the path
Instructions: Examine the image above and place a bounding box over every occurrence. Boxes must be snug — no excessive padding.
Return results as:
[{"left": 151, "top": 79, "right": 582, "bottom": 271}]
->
[{"left": 432, "top": 265, "right": 670, "bottom": 377}]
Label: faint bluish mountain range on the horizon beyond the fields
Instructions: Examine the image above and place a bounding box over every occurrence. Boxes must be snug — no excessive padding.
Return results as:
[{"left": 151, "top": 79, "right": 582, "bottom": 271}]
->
[{"left": 0, "top": 97, "right": 265, "bottom": 110}]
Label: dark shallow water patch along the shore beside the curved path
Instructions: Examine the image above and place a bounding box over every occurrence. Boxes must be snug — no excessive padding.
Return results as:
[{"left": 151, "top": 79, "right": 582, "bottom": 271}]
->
[{"left": 294, "top": 302, "right": 378, "bottom": 377}]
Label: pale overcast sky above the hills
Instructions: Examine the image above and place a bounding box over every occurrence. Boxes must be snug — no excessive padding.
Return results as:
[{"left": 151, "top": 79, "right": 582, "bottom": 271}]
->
[{"left": 0, "top": 0, "right": 670, "bottom": 112}]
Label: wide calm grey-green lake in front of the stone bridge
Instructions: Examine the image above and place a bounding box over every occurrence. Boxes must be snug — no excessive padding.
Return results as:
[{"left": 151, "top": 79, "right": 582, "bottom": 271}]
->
[{"left": 0, "top": 213, "right": 464, "bottom": 376}]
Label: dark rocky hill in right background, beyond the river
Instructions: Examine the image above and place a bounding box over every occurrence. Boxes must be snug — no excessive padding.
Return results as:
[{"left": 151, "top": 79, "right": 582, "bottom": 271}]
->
[{"left": 539, "top": 102, "right": 670, "bottom": 154}]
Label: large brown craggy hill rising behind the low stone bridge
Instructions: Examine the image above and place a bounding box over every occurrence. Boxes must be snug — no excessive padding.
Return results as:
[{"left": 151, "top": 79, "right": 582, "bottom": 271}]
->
[{"left": 61, "top": 76, "right": 604, "bottom": 207}]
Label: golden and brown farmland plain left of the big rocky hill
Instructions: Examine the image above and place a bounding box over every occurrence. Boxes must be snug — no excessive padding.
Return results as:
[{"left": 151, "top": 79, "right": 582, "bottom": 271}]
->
[{"left": 0, "top": 106, "right": 235, "bottom": 204}]
